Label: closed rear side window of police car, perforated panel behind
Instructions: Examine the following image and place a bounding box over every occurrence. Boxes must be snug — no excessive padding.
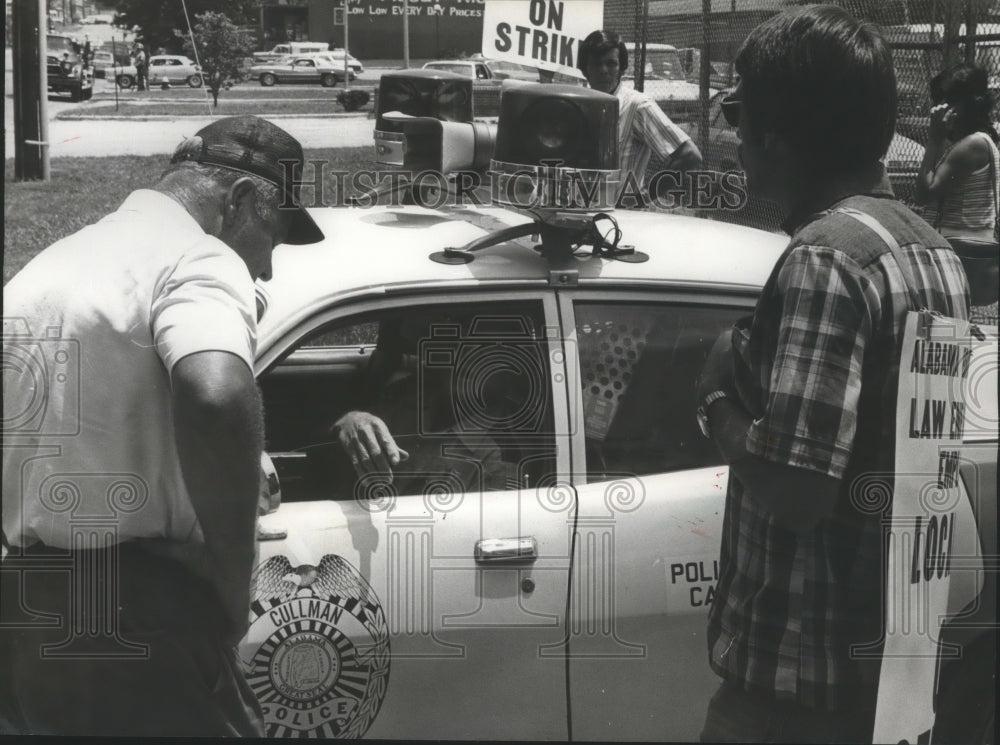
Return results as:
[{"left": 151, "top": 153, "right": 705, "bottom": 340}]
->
[{"left": 576, "top": 302, "right": 745, "bottom": 482}]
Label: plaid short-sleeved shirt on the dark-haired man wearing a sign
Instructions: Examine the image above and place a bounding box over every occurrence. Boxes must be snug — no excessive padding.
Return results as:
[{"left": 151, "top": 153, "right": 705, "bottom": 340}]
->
[{"left": 708, "top": 172, "right": 969, "bottom": 710}]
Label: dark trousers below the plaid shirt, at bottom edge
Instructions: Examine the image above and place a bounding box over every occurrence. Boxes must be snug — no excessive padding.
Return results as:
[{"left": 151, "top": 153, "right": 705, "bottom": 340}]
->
[{"left": 701, "top": 681, "right": 875, "bottom": 743}]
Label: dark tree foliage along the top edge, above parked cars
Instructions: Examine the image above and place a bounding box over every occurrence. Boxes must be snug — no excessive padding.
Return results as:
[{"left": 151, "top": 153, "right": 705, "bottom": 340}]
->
[{"left": 115, "top": 0, "right": 259, "bottom": 52}]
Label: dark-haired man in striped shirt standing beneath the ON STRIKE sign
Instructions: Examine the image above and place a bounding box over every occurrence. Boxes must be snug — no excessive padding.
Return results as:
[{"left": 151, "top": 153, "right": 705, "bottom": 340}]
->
[{"left": 578, "top": 30, "right": 701, "bottom": 201}]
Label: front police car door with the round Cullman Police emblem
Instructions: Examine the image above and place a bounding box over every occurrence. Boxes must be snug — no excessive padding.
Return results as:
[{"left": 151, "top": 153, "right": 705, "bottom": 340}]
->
[{"left": 240, "top": 292, "right": 575, "bottom": 740}]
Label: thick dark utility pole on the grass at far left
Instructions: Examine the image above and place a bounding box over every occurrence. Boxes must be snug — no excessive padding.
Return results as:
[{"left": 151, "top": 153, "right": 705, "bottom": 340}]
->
[{"left": 11, "top": 0, "right": 49, "bottom": 181}]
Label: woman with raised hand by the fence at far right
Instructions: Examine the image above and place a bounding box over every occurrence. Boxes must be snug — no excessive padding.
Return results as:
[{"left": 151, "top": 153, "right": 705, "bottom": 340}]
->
[{"left": 915, "top": 63, "right": 1000, "bottom": 326}]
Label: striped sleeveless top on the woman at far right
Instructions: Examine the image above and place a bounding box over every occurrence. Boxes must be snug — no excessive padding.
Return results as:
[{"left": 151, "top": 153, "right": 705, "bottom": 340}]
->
[{"left": 924, "top": 132, "right": 1000, "bottom": 240}]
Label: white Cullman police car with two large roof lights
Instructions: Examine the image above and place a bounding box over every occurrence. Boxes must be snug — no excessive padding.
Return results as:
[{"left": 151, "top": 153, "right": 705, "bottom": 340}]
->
[{"left": 239, "top": 71, "right": 996, "bottom": 741}]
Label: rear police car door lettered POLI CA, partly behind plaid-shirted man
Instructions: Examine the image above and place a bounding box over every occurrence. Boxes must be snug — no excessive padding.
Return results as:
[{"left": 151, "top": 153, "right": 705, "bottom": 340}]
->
[{"left": 560, "top": 290, "right": 752, "bottom": 741}]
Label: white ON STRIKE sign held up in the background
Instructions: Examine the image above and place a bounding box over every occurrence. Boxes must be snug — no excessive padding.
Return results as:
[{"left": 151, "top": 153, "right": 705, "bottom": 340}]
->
[{"left": 482, "top": 0, "right": 604, "bottom": 74}]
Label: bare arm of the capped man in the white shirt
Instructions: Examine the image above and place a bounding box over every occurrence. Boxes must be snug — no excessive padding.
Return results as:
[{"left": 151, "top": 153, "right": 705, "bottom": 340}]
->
[{"left": 171, "top": 352, "right": 264, "bottom": 639}]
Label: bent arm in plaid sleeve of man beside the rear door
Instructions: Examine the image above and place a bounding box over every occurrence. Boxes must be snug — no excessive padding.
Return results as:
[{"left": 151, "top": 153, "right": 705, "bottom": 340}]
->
[{"left": 697, "top": 246, "right": 878, "bottom": 531}]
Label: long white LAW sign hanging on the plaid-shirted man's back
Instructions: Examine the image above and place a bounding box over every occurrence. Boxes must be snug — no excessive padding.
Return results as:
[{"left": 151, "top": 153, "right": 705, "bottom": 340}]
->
[{"left": 873, "top": 312, "right": 998, "bottom": 744}]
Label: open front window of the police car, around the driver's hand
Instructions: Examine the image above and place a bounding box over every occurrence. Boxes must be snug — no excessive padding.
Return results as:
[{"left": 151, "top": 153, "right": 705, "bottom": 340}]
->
[{"left": 261, "top": 301, "right": 556, "bottom": 501}]
